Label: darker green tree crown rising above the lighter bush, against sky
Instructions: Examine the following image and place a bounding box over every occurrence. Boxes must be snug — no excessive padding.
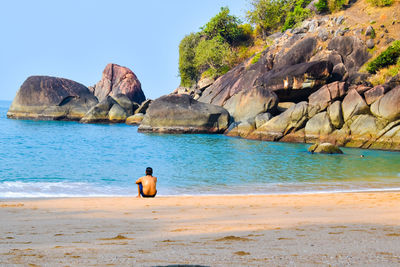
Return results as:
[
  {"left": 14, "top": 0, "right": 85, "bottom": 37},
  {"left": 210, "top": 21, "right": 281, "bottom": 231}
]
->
[{"left": 201, "top": 7, "right": 244, "bottom": 45}]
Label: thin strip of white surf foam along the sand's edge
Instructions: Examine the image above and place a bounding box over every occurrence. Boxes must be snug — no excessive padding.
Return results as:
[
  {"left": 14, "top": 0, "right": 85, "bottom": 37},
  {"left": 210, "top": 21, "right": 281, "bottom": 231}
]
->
[{"left": 0, "top": 181, "right": 400, "bottom": 198}]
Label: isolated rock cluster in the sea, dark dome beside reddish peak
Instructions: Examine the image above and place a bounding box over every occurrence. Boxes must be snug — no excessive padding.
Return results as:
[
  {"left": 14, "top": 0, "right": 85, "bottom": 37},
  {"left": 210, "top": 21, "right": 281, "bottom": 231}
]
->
[{"left": 7, "top": 64, "right": 151, "bottom": 123}]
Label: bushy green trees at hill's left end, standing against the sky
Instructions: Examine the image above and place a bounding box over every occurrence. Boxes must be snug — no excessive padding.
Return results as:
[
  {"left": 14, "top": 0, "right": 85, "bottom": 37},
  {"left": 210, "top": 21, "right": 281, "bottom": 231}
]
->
[{"left": 179, "top": 7, "right": 253, "bottom": 87}]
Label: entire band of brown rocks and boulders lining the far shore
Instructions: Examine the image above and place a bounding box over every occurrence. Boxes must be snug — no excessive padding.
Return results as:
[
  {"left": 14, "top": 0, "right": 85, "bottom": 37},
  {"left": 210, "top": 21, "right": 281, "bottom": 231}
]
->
[{"left": 7, "top": 17, "right": 400, "bottom": 150}]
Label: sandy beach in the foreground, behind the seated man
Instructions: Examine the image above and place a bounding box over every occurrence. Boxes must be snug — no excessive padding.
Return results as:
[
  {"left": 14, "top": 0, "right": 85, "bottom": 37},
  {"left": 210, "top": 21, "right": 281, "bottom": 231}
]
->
[{"left": 0, "top": 192, "right": 400, "bottom": 266}]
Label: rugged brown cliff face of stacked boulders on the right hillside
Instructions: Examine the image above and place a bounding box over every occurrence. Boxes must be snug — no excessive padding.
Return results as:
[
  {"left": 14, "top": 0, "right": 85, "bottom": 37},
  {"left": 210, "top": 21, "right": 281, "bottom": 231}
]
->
[{"left": 186, "top": 8, "right": 400, "bottom": 150}]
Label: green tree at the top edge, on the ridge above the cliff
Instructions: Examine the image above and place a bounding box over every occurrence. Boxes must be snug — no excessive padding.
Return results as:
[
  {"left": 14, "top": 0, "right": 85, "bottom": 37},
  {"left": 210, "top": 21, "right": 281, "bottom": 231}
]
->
[{"left": 247, "top": 0, "right": 286, "bottom": 39}]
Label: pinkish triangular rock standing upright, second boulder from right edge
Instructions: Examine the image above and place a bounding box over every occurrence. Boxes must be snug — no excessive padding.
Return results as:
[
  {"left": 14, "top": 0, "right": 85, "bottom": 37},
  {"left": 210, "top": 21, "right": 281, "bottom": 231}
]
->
[{"left": 342, "top": 89, "right": 369, "bottom": 121}]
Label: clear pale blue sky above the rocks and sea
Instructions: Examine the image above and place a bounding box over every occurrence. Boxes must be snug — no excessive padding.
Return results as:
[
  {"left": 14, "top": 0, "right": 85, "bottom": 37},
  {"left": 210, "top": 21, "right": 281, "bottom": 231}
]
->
[{"left": 0, "top": 0, "right": 249, "bottom": 100}]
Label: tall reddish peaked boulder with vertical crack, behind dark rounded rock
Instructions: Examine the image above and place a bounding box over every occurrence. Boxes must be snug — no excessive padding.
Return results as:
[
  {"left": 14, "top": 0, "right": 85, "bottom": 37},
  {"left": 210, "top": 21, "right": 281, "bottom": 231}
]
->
[{"left": 93, "top": 63, "right": 146, "bottom": 104}]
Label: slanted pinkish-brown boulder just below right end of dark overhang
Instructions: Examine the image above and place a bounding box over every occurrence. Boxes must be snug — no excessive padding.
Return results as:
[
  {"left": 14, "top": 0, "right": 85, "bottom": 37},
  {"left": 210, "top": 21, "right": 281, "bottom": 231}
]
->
[{"left": 308, "top": 82, "right": 346, "bottom": 117}]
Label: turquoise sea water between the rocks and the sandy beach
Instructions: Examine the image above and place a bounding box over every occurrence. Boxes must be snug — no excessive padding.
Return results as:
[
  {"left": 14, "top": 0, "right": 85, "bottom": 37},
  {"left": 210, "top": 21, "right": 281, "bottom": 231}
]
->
[{"left": 0, "top": 101, "right": 400, "bottom": 198}]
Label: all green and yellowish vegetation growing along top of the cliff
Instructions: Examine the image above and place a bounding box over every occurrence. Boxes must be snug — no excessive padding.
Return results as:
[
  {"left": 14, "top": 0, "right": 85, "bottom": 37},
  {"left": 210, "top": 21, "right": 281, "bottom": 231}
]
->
[{"left": 179, "top": 0, "right": 397, "bottom": 87}]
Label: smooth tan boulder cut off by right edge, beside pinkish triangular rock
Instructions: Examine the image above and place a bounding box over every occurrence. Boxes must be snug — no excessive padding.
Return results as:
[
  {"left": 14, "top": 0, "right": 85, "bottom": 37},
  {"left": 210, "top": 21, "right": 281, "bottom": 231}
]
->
[{"left": 371, "top": 86, "right": 400, "bottom": 121}]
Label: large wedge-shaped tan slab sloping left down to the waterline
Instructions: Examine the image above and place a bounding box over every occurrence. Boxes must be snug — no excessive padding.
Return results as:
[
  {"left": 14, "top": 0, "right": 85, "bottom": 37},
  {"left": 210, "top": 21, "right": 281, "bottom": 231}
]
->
[{"left": 248, "top": 101, "right": 308, "bottom": 141}]
